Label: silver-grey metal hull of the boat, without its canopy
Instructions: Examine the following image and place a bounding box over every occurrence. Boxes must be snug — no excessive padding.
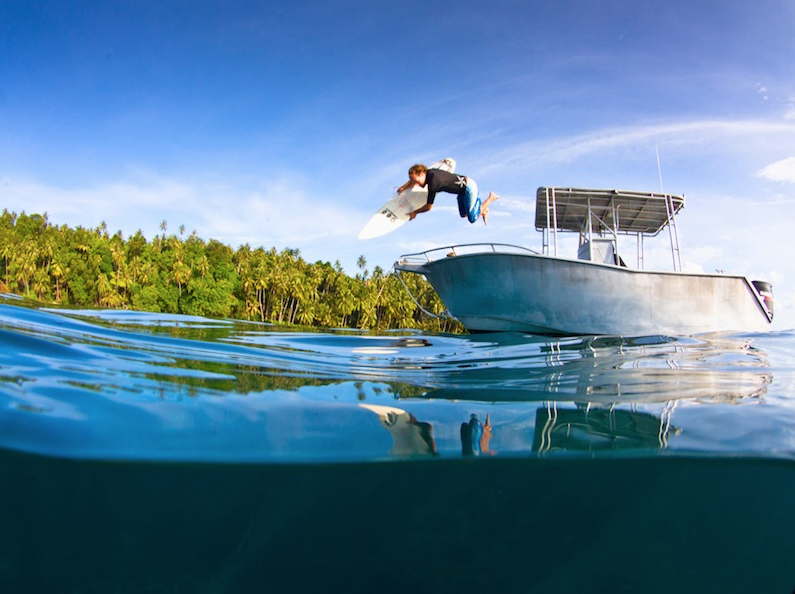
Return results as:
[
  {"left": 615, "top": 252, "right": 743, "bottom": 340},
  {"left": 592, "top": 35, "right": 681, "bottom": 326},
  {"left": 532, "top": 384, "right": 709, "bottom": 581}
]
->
[{"left": 395, "top": 252, "right": 771, "bottom": 336}]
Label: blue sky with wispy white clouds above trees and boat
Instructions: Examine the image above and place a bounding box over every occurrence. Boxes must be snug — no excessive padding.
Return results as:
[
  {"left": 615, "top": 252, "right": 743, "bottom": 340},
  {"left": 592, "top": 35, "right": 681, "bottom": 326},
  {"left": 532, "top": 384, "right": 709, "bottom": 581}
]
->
[{"left": 0, "top": 0, "right": 795, "bottom": 330}]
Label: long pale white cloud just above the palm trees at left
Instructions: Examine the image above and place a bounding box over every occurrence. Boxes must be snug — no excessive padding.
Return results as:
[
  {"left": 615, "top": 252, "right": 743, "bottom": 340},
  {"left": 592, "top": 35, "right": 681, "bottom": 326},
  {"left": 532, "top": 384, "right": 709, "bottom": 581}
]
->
[{"left": 1, "top": 171, "right": 356, "bottom": 247}]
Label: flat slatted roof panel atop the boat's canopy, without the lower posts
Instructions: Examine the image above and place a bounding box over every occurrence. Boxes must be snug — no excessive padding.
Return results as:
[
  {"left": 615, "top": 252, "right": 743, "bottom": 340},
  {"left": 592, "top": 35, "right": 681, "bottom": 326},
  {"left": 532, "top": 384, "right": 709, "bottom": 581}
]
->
[{"left": 536, "top": 187, "right": 685, "bottom": 235}]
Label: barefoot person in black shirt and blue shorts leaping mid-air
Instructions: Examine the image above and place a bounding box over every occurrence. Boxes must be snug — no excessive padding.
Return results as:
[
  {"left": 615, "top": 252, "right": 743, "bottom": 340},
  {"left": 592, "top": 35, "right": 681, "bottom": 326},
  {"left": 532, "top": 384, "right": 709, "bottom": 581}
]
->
[{"left": 398, "top": 164, "right": 499, "bottom": 223}]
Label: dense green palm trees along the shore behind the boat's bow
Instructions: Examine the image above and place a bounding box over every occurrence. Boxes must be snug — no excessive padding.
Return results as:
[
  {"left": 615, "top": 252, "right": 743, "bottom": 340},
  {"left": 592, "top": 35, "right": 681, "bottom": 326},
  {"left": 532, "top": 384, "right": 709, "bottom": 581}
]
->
[{"left": 0, "top": 209, "right": 464, "bottom": 332}]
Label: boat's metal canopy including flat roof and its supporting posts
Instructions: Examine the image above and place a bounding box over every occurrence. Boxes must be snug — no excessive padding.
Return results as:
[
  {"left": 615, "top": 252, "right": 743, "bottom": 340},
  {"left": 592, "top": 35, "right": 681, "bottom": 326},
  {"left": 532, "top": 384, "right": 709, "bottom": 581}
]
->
[{"left": 535, "top": 186, "right": 685, "bottom": 271}]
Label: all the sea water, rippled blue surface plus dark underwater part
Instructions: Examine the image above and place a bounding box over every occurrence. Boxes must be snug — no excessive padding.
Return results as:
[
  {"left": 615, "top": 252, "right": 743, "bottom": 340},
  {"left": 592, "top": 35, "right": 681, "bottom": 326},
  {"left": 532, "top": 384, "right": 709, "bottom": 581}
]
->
[{"left": 0, "top": 296, "right": 795, "bottom": 594}]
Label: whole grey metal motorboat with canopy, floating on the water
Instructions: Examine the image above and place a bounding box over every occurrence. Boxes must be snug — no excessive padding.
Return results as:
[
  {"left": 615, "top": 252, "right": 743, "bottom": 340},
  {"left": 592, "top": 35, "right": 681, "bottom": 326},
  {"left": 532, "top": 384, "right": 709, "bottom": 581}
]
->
[{"left": 394, "top": 187, "right": 773, "bottom": 336}]
